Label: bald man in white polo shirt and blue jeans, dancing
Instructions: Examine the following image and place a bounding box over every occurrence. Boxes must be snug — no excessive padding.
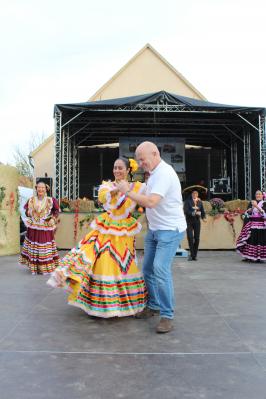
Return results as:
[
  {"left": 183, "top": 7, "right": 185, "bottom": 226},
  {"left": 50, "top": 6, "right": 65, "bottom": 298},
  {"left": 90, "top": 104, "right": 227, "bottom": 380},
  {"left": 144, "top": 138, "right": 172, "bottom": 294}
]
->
[{"left": 118, "top": 141, "right": 187, "bottom": 333}]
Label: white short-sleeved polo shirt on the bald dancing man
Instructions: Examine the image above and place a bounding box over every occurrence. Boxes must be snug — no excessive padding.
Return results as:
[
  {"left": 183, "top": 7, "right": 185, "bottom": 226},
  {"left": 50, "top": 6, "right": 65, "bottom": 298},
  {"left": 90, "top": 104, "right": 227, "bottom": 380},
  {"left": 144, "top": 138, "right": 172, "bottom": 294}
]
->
[{"left": 146, "top": 160, "right": 187, "bottom": 232}]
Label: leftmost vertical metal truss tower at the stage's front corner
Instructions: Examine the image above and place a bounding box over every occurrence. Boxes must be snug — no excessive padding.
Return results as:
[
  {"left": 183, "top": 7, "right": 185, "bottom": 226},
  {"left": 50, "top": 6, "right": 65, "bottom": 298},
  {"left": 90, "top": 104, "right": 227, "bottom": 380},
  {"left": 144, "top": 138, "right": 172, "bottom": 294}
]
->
[{"left": 54, "top": 111, "right": 62, "bottom": 200}]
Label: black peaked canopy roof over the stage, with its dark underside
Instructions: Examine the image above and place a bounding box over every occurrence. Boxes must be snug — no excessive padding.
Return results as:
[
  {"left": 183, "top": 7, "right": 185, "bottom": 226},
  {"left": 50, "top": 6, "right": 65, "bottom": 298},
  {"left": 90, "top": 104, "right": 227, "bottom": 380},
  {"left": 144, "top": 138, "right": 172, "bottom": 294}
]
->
[{"left": 54, "top": 91, "right": 265, "bottom": 146}]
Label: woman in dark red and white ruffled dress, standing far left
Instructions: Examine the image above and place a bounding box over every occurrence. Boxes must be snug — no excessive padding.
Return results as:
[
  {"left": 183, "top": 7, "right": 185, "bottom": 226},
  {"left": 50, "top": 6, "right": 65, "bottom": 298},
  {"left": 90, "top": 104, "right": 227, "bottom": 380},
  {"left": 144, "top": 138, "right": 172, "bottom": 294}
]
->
[{"left": 19, "top": 181, "right": 59, "bottom": 274}]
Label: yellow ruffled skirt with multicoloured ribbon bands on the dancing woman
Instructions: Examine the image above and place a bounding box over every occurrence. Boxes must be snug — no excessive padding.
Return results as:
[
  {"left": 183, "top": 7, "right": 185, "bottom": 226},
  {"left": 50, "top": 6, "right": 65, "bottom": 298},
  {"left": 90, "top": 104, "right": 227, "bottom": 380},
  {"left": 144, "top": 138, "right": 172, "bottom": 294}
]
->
[{"left": 48, "top": 230, "right": 147, "bottom": 318}]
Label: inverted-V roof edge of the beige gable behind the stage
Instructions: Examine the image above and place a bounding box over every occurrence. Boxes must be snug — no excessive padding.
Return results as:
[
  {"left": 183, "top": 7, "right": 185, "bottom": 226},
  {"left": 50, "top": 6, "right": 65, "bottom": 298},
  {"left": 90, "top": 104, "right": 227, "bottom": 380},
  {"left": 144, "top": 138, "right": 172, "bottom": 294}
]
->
[{"left": 89, "top": 43, "right": 206, "bottom": 101}]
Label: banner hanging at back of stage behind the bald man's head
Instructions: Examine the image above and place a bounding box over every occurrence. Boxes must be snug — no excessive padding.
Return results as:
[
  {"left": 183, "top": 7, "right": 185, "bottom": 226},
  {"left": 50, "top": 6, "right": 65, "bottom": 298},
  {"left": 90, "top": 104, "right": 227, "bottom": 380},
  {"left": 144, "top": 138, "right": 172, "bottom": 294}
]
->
[{"left": 119, "top": 137, "right": 185, "bottom": 173}]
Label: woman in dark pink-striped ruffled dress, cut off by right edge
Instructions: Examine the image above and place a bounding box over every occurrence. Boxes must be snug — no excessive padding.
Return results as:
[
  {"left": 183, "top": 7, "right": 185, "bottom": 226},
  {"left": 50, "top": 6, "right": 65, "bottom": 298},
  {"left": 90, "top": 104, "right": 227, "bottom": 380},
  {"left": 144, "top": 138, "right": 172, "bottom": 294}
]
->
[{"left": 236, "top": 190, "right": 266, "bottom": 262}]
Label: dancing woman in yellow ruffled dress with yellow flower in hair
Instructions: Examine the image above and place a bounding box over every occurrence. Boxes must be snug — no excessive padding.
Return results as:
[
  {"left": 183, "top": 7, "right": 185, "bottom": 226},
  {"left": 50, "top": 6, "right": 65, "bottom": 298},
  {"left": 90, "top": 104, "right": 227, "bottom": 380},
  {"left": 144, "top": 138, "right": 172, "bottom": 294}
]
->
[{"left": 48, "top": 158, "right": 146, "bottom": 318}]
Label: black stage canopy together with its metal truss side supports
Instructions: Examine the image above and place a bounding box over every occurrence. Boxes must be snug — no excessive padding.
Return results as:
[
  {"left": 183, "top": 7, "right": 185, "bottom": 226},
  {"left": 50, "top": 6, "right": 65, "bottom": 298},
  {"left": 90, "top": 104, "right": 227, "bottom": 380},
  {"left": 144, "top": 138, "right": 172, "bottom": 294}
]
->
[{"left": 54, "top": 91, "right": 266, "bottom": 199}]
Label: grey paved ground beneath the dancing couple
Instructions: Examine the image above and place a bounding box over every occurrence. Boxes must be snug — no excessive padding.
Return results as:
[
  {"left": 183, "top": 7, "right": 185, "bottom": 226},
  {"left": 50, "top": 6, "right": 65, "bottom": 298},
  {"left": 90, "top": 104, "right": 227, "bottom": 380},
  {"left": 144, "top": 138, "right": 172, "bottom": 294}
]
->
[{"left": 0, "top": 251, "right": 266, "bottom": 399}]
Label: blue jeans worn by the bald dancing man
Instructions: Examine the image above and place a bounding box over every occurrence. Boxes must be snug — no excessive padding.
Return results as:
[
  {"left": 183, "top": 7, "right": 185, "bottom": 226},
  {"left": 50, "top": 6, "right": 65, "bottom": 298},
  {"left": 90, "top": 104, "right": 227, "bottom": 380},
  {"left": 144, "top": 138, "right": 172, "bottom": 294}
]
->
[{"left": 142, "top": 230, "right": 185, "bottom": 319}]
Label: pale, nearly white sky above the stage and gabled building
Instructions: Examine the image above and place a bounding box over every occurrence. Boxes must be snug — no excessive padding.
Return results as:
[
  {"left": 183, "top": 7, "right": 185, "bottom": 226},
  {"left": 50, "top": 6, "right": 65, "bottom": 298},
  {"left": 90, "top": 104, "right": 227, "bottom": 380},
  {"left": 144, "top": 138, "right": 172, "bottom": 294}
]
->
[{"left": 0, "top": 0, "right": 266, "bottom": 163}]
